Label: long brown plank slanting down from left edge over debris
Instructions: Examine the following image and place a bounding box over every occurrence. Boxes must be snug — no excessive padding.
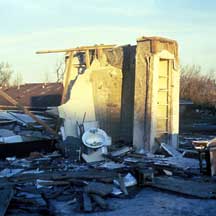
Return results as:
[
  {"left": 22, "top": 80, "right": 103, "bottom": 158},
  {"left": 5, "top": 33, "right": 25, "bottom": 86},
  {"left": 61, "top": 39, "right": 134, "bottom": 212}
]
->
[{"left": 0, "top": 89, "right": 58, "bottom": 136}]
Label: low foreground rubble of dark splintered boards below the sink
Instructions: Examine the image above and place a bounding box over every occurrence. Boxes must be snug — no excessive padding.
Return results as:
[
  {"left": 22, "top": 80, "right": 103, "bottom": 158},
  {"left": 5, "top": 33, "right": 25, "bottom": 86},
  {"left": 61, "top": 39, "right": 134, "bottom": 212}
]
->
[{"left": 0, "top": 144, "right": 216, "bottom": 215}]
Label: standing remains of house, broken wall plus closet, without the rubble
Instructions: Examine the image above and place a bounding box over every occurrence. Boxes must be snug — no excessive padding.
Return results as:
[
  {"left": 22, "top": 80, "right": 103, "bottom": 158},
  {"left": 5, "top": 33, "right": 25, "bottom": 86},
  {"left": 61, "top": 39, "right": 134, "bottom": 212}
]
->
[{"left": 39, "top": 37, "right": 179, "bottom": 152}]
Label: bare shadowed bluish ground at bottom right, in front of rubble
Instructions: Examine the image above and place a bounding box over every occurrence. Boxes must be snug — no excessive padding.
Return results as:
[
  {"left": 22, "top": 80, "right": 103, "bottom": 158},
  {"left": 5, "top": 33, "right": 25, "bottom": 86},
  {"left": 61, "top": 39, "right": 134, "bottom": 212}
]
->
[{"left": 52, "top": 188, "right": 216, "bottom": 216}]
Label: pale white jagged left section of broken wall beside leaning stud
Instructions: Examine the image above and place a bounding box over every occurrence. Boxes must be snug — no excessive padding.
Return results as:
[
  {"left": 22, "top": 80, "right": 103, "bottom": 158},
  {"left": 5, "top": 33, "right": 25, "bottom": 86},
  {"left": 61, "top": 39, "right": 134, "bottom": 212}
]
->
[{"left": 58, "top": 54, "right": 95, "bottom": 137}]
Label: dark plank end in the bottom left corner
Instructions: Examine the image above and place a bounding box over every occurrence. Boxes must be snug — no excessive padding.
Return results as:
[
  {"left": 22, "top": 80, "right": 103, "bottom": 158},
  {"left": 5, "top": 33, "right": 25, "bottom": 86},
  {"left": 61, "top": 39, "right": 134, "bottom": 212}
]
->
[{"left": 0, "top": 187, "right": 14, "bottom": 216}]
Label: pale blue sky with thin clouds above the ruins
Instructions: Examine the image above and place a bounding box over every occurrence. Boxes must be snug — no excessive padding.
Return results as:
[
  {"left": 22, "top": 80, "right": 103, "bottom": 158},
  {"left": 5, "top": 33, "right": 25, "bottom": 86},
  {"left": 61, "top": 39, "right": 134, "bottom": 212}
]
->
[{"left": 0, "top": 0, "right": 216, "bottom": 82}]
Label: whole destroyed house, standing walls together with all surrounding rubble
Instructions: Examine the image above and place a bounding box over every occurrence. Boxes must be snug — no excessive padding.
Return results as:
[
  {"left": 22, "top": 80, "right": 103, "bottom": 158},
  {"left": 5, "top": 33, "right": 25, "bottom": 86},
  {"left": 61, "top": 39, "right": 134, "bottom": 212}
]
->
[{"left": 0, "top": 37, "right": 216, "bottom": 216}]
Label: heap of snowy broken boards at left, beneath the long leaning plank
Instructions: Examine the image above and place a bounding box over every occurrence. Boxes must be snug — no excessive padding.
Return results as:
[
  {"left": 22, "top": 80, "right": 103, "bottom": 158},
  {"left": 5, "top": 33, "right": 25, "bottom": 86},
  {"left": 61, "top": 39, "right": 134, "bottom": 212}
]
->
[{"left": 0, "top": 110, "right": 58, "bottom": 158}]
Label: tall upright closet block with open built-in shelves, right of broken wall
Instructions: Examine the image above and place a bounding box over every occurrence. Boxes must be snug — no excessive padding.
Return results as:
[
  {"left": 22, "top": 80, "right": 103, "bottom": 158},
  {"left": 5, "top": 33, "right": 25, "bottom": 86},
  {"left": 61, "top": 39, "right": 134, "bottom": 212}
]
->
[{"left": 133, "top": 37, "right": 179, "bottom": 152}]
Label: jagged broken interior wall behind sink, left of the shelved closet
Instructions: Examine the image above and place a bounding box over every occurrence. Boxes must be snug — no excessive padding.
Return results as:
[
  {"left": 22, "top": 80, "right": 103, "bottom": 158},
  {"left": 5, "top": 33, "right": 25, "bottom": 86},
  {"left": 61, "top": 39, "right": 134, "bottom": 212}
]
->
[{"left": 59, "top": 45, "right": 136, "bottom": 143}]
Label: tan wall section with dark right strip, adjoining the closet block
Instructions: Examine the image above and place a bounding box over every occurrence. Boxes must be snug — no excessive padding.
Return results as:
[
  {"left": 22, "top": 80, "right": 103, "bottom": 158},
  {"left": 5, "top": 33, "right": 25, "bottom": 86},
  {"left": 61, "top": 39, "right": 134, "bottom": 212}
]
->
[{"left": 91, "top": 45, "right": 135, "bottom": 142}]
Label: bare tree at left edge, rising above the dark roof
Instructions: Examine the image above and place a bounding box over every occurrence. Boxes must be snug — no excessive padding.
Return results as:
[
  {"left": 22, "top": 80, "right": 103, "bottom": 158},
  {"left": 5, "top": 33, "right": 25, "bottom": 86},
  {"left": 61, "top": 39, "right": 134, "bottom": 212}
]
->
[{"left": 0, "top": 62, "right": 13, "bottom": 87}]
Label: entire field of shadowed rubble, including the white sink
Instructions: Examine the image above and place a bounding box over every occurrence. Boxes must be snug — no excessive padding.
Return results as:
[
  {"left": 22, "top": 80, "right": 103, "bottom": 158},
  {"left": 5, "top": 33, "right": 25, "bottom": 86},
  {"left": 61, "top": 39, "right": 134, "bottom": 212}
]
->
[{"left": 0, "top": 107, "right": 216, "bottom": 216}]
